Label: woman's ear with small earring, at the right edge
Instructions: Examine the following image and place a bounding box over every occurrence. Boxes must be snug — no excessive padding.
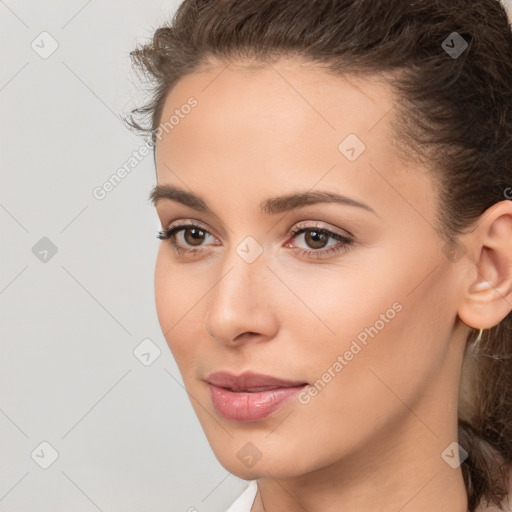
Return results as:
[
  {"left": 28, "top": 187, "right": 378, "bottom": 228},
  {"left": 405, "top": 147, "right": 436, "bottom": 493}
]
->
[{"left": 458, "top": 200, "right": 512, "bottom": 329}]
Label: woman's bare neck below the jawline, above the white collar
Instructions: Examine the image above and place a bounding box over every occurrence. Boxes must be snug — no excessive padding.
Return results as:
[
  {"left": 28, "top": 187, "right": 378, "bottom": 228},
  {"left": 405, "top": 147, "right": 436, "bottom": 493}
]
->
[{"left": 252, "top": 388, "right": 468, "bottom": 512}]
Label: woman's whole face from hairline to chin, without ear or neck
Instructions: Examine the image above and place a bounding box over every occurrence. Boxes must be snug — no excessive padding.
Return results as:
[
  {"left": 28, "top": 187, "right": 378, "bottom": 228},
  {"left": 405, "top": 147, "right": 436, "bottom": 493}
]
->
[{"left": 155, "top": 59, "right": 464, "bottom": 479}]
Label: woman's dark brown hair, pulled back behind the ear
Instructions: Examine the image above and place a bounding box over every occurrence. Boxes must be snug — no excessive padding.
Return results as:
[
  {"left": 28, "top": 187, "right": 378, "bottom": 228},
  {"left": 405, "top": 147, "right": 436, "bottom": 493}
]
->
[{"left": 127, "top": 0, "right": 512, "bottom": 512}]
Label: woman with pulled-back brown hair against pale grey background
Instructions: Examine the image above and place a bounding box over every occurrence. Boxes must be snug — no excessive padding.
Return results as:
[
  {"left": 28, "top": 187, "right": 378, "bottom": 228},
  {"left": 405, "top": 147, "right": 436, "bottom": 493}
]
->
[{"left": 126, "top": 0, "right": 512, "bottom": 512}]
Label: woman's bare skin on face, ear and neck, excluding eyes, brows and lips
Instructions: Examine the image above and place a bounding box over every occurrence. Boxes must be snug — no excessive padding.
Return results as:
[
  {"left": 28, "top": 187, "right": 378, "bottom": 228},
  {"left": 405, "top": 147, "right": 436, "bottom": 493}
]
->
[{"left": 150, "top": 58, "right": 512, "bottom": 512}]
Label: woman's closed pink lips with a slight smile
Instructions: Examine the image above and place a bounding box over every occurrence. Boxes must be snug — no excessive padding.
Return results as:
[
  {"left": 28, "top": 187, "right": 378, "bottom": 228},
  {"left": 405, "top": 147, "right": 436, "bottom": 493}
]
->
[{"left": 205, "top": 372, "right": 307, "bottom": 421}]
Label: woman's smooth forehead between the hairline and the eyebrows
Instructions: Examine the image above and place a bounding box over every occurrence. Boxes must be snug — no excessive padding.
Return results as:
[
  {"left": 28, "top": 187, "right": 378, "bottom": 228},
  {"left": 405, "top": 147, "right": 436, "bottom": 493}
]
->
[{"left": 156, "top": 59, "right": 433, "bottom": 224}]
